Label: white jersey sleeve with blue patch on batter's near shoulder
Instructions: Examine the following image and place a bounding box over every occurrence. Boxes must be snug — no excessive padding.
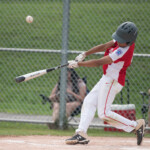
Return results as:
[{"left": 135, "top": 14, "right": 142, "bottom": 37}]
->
[{"left": 109, "top": 46, "right": 129, "bottom": 61}]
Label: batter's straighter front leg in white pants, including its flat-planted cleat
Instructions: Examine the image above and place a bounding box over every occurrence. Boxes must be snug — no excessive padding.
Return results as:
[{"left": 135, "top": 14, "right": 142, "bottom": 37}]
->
[{"left": 66, "top": 81, "right": 100, "bottom": 144}]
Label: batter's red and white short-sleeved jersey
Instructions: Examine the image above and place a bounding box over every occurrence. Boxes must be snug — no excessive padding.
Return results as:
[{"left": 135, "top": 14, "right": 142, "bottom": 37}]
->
[{"left": 103, "top": 42, "right": 135, "bottom": 86}]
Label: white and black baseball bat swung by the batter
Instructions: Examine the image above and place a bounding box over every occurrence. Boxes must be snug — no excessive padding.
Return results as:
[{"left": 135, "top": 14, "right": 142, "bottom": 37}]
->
[{"left": 15, "top": 63, "right": 68, "bottom": 83}]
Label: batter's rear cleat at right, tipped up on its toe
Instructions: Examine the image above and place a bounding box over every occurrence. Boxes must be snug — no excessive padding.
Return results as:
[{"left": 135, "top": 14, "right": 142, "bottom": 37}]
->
[{"left": 135, "top": 119, "right": 145, "bottom": 145}]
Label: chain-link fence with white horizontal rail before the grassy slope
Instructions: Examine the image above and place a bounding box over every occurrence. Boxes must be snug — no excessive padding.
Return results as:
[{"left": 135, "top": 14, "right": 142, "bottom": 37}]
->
[{"left": 0, "top": 0, "right": 150, "bottom": 129}]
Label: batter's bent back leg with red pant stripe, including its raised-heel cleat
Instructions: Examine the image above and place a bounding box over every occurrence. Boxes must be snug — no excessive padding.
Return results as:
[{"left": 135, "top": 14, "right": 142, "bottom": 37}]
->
[{"left": 98, "top": 76, "right": 145, "bottom": 145}]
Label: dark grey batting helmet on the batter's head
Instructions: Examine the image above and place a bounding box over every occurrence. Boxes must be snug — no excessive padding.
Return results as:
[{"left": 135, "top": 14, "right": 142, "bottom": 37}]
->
[{"left": 112, "top": 22, "right": 138, "bottom": 45}]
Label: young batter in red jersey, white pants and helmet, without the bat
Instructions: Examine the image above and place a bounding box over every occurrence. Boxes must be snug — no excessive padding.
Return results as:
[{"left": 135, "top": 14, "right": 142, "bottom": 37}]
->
[{"left": 66, "top": 22, "right": 145, "bottom": 145}]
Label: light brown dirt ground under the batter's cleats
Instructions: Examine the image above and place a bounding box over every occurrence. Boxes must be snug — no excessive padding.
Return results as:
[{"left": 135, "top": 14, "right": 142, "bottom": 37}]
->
[{"left": 0, "top": 135, "right": 150, "bottom": 150}]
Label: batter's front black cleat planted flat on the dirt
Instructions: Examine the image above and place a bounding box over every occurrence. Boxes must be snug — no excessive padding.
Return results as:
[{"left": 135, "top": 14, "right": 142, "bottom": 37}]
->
[{"left": 66, "top": 132, "right": 89, "bottom": 145}]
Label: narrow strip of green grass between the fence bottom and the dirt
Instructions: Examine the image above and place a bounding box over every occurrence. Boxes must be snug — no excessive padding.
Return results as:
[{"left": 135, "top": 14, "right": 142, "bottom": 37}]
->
[{"left": 0, "top": 122, "right": 150, "bottom": 138}]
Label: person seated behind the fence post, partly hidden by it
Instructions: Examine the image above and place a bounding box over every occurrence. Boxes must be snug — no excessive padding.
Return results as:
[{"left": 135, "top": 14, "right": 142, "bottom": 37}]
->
[{"left": 49, "top": 69, "right": 86, "bottom": 122}]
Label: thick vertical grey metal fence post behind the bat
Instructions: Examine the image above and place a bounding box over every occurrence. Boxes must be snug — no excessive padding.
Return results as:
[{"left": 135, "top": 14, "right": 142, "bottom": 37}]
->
[{"left": 59, "top": 0, "right": 70, "bottom": 129}]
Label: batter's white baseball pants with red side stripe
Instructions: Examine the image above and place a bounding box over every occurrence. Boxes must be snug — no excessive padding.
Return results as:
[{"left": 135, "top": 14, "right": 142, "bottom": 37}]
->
[{"left": 76, "top": 75, "right": 137, "bottom": 133}]
